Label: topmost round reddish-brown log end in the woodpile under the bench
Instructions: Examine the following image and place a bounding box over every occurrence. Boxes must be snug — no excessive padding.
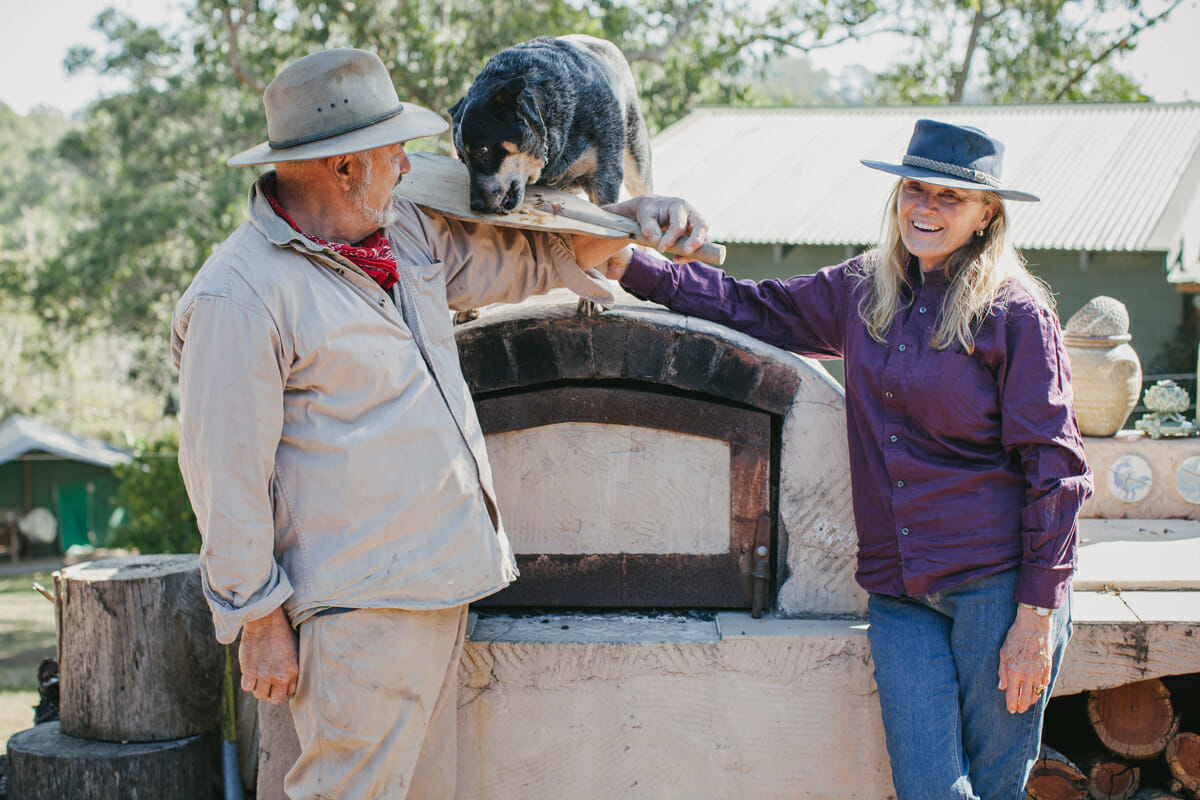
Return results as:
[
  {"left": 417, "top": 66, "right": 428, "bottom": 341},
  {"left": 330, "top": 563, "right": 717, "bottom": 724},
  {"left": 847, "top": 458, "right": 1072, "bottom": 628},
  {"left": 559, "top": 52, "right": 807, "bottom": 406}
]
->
[{"left": 1087, "top": 679, "right": 1180, "bottom": 758}]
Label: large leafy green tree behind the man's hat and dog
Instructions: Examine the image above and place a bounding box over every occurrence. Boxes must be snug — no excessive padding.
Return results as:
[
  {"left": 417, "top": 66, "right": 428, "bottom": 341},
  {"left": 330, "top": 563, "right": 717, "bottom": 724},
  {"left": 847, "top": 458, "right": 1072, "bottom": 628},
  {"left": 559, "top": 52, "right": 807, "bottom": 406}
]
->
[{"left": 31, "top": 0, "right": 857, "bottom": 367}]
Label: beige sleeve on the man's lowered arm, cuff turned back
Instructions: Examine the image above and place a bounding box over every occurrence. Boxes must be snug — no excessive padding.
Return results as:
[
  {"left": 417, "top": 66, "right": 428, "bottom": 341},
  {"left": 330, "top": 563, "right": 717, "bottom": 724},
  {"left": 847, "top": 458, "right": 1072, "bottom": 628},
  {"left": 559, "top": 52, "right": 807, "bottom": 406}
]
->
[{"left": 172, "top": 287, "right": 292, "bottom": 644}]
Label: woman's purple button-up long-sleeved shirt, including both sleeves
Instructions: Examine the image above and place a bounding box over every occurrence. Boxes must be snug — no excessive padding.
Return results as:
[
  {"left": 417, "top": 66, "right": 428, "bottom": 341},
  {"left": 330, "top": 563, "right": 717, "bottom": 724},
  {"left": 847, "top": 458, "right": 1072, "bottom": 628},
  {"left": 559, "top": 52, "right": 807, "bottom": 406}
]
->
[{"left": 620, "top": 253, "right": 1092, "bottom": 608}]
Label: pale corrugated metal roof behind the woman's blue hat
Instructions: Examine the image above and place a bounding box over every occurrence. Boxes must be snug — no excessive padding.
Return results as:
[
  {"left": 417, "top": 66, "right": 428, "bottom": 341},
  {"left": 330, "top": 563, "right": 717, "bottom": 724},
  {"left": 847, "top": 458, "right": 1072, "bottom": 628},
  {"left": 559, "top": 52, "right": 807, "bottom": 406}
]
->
[{"left": 653, "top": 103, "right": 1200, "bottom": 251}]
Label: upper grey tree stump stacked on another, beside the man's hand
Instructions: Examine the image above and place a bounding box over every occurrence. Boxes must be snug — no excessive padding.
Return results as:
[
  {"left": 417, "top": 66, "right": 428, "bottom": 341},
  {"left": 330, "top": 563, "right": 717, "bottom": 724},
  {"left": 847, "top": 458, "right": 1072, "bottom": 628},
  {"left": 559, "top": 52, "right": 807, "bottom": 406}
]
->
[{"left": 54, "top": 555, "right": 223, "bottom": 742}]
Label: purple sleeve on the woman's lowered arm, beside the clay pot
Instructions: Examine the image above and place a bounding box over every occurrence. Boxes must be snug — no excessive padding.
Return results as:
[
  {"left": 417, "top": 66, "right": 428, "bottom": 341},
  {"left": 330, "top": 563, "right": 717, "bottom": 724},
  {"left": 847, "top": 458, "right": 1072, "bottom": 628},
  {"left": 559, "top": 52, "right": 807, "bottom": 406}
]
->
[{"left": 1000, "top": 303, "right": 1092, "bottom": 608}]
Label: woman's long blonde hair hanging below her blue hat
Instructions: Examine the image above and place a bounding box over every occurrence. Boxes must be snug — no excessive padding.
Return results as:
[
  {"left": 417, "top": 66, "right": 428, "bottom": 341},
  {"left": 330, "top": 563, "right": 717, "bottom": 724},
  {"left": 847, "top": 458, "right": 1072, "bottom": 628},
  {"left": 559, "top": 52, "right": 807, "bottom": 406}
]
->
[{"left": 858, "top": 179, "right": 1054, "bottom": 353}]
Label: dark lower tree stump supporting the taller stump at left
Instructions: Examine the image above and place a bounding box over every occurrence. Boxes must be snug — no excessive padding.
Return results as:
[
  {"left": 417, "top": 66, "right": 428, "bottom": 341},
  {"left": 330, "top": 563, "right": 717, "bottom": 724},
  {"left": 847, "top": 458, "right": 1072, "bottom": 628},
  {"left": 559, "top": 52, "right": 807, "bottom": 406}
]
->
[{"left": 8, "top": 722, "right": 218, "bottom": 800}]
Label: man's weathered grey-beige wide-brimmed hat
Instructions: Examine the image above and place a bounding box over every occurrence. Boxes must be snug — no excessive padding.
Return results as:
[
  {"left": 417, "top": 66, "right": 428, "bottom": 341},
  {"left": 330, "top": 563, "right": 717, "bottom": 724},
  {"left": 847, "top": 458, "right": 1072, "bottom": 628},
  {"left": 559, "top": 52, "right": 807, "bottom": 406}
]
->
[{"left": 227, "top": 48, "right": 449, "bottom": 167}]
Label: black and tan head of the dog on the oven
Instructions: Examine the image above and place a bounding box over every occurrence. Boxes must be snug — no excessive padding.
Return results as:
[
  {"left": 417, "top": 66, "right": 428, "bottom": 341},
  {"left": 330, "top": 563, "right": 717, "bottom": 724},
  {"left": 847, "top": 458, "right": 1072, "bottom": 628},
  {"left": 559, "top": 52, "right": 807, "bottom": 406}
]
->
[{"left": 450, "top": 76, "right": 546, "bottom": 213}]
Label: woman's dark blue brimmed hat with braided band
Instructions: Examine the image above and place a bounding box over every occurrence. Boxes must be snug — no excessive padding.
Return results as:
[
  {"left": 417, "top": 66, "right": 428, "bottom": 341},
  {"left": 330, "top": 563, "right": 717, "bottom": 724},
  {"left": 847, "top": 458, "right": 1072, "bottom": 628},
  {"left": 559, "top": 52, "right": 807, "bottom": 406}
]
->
[{"left": 862, "top": 120, "right": 1038, "bottom": 203}]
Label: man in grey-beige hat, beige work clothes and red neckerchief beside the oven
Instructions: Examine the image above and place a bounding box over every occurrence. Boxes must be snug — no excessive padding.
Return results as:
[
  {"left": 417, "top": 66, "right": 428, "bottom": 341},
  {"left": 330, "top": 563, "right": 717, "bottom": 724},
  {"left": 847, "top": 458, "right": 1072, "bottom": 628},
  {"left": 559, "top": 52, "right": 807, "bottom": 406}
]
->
[{"left": 172, "top": 49, "right": 706, "bottom": 800}]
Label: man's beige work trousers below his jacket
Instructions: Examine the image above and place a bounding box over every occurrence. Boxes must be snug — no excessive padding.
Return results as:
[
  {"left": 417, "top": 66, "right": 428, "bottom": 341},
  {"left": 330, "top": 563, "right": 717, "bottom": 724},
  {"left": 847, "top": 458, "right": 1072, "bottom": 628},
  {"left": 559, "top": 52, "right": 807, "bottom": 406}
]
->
[{"left": 283, "top": 606, "right": 467, "bottom": 800}]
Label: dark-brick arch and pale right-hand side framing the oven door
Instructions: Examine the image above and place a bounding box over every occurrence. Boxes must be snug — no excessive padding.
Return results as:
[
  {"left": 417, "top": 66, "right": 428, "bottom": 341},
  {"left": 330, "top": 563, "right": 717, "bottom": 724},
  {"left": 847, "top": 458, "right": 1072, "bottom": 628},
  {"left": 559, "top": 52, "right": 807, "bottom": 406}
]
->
[{"left": 456, "top": 293, "right": 865, "bottom": 615}]
